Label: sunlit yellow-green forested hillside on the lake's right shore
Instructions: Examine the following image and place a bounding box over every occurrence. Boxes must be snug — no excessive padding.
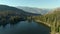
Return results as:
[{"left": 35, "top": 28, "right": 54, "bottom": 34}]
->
[{"left": 34, "top": 8, "right": 60, "bottom": 34}]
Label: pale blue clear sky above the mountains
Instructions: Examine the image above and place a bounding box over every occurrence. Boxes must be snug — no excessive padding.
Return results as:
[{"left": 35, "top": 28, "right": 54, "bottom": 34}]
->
[{"left": 0, "top": 0, "right": 60, "bottom": 8}]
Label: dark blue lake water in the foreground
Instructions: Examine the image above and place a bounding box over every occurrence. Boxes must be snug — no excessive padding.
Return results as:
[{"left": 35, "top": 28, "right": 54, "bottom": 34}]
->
[{"left": 0, "top": 21, "right": 50, "bottom": 34}]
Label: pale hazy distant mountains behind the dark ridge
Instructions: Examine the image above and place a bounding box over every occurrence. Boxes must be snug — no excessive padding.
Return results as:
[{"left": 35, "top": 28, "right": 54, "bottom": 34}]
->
[{"left": 16, "top": 6, "right": 51, "bottom": 15}]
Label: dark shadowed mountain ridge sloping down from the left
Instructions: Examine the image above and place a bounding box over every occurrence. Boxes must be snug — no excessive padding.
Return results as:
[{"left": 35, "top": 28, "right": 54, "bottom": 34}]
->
[{"left": 0, "top": 5, "right": 41, "bottom": 16}]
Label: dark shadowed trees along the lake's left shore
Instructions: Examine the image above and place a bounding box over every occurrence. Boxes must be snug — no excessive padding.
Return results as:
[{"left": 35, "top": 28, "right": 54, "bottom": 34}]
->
[{"left": 0, "top": 11, "right": 25, "bottom": 25}]
